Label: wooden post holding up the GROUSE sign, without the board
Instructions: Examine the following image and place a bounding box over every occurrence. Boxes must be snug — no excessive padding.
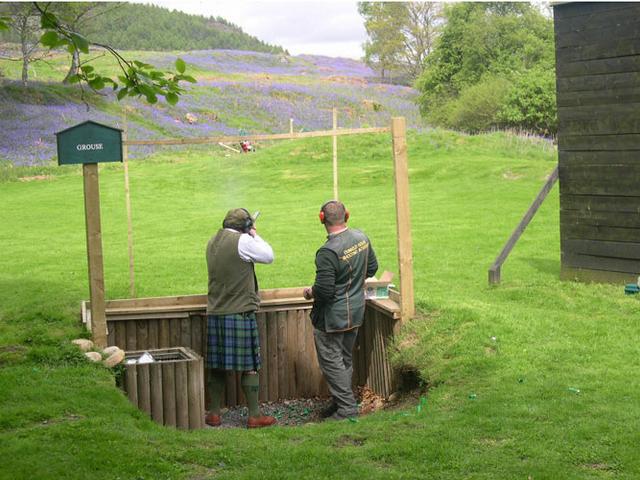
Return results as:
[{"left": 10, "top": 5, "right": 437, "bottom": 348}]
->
[{"left": 82, "top": 163, "right": 107, "bottom": 348}]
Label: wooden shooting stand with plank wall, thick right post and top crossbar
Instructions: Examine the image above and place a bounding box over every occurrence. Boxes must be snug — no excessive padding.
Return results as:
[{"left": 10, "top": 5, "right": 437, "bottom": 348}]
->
[{"left": 82, "top": 117, "right": 415, "bottom": 412}]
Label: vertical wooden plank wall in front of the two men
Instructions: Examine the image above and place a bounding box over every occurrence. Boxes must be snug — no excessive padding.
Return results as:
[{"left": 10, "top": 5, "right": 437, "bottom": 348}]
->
[{"left": 107, "top": 305, "right": 398, "bottom": 405}]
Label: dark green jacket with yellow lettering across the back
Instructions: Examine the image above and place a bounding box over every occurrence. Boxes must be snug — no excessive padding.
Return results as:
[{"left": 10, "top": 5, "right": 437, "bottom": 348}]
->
[{"left": 311, "top": 228, "right": 378, "bottom": 332}]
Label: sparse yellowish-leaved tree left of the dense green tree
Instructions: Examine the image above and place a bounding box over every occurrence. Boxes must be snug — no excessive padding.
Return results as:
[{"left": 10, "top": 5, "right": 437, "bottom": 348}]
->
[{"left": 358, "top": 2, "right": 442, "bottom": 80}]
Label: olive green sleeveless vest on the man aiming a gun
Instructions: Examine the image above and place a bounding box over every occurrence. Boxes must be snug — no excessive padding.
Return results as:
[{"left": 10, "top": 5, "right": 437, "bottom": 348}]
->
[{"left": 207, "top": 229, "right": 260, "bottom": 315}]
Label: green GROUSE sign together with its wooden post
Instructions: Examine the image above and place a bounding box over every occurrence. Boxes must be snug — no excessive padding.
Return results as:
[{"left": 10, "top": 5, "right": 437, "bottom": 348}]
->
[{"left": 56, "top": 121, "right": 122, "bottom": 348}]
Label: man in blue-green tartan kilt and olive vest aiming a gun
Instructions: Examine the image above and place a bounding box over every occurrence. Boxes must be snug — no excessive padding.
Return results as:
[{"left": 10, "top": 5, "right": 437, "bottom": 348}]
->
[{"left": 205, "top": 208, "right": 276, "bottom": 428}]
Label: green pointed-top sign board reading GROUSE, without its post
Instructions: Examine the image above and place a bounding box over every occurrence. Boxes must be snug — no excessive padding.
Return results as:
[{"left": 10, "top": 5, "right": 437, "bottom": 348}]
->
[{"left": 56, "top": 120, "right": 122, "bottom": 165}]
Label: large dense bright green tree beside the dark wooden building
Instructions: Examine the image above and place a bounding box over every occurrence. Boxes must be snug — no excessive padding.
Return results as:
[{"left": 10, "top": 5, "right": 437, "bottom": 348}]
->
[{"left": 416, "top": 2, "right": 555, "bottom": 133}]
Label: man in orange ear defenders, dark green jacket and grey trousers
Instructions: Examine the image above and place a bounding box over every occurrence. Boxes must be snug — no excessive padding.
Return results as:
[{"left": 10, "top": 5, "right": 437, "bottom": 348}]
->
[{"left": 304, "top": 200, "right": 378, "bottom": 420}]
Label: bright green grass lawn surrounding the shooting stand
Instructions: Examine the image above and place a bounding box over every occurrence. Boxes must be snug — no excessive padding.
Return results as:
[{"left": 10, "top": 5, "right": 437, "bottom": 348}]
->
[{"left": 0, "top": 131, "right": 640, "bottom": 480}]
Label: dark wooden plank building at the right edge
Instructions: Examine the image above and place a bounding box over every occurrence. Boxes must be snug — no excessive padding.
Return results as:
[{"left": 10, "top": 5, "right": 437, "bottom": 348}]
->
[{"left": 554, "top": 2, "right": 640, "bottom": 282}]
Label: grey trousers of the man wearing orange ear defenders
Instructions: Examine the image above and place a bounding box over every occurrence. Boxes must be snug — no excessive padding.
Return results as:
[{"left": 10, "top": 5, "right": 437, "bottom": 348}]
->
[{"left": 313, "top": 328, "right": 358, "bottom": 417}]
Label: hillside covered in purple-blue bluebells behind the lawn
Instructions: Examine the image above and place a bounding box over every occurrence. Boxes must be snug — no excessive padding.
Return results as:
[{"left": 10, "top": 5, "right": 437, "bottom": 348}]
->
[{"left": 0, "top": 50, "right": 421, "bottom": 168}]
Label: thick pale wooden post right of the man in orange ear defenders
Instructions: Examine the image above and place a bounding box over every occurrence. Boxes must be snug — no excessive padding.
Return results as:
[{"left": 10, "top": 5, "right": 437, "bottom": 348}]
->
[{"left": 391, "top": 117, "right": 415, "bottom": 321}]
